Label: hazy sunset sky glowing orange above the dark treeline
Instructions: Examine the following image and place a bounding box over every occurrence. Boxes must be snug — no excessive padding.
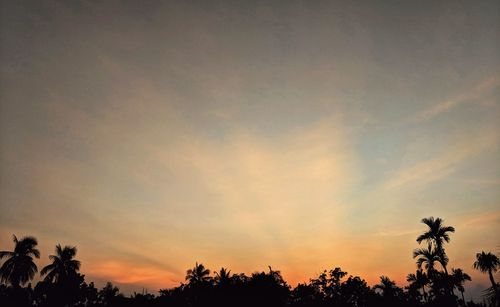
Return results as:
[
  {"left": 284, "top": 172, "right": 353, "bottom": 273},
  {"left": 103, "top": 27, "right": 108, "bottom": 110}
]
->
[{"left": 0, "top": 1, "right": 500, "bottom": 304}]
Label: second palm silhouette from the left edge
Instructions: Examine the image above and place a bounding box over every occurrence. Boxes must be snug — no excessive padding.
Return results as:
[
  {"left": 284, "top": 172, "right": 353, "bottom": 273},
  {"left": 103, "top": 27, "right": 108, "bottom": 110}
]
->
[{"left": 40, "top": 244, "right": 80, "bottom": 283}]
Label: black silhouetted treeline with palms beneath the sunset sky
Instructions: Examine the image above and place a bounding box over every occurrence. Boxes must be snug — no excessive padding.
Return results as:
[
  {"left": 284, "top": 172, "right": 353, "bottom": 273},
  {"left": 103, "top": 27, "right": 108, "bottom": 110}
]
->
[{"left": 0, "top": 217, "right": 500, "bottom": 307}]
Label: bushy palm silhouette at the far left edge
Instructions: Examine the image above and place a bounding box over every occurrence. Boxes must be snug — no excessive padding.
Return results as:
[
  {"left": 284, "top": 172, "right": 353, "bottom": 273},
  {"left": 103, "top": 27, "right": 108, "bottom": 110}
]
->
[{"left": 0, "top": 235, "right": 40, "bottom": 288}]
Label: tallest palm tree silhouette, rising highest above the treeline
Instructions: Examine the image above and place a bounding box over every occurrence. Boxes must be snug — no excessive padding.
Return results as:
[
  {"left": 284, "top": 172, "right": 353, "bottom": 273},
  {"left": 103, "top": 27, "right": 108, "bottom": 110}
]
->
[{"left": 417, "top": 216, "right": 455, "bottom": 275}]
